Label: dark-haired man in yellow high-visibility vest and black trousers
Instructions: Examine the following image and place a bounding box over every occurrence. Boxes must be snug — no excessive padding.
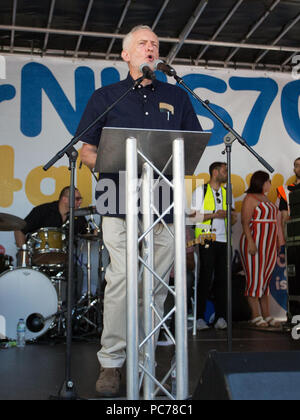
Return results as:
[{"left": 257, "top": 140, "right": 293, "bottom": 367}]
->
[{"left": 191, "top": 162, "right": 237, "bottom": 331}]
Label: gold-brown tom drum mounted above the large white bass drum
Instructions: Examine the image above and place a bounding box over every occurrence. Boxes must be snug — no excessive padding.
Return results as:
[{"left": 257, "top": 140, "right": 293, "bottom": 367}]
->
[{"left": 29, "top": 227, "right": 67, "bottom": 266}]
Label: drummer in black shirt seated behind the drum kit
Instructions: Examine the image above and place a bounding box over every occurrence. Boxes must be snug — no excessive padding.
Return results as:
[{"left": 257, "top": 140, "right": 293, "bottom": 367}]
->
[{"left": 14, "top": 187, "right": 87, "bottom": 248}]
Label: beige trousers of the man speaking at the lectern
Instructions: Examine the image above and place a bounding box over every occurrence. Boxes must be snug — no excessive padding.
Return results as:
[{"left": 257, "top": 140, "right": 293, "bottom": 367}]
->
[{"left": 97, "top": 217, "right": 174, "bottom": 368}]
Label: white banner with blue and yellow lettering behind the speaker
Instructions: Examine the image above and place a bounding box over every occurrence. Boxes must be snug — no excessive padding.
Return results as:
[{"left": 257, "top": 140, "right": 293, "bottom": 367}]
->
[{"left": 0, "top": 55, "right": 300, "bottom": 318}]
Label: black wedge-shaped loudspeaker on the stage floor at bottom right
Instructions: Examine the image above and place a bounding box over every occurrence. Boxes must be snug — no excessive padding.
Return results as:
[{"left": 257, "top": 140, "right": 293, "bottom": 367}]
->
[{"left": 192, "top": 351, "right": 300, "bottom": 401}]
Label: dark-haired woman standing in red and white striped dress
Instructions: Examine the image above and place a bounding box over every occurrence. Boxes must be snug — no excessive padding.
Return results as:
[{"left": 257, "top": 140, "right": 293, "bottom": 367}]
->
[{"left": 240, "top": 171, "right": 278, "bottom": 328}]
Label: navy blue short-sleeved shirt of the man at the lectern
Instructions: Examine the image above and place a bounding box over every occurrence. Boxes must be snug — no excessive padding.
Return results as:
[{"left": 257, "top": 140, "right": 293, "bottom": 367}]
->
[{"left": 76, "top": 74, "right": 201, "bottom": 222}]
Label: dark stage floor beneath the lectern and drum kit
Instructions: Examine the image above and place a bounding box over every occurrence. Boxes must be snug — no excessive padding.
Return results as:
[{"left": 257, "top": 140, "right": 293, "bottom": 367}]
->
[{"left": 0, "top": 324, "right": 300, "bottom": 400}]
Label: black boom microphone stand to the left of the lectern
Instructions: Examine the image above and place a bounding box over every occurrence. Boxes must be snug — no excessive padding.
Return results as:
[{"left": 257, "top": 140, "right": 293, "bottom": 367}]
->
[{"left": 43, "top": 74, "right": 147, "bottom": 400}]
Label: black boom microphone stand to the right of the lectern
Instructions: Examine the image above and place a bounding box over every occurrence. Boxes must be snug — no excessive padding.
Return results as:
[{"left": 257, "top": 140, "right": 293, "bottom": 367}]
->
[{"left": 169, "top": 68, "right": 274, "bottom": 352}]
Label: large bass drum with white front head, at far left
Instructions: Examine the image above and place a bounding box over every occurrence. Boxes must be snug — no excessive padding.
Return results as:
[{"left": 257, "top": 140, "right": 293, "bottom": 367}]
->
[{"left": 0, "top": 268, "right": 58, "bottom": 340}]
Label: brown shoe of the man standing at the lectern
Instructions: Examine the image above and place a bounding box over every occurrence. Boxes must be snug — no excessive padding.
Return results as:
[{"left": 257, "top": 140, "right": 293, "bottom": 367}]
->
[{"left": 96, "top": 367, "right": 121, "bottom": 398}]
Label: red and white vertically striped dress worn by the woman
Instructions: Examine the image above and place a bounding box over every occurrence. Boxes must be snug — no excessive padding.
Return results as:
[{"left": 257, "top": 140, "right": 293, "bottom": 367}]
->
[{"left": 240, "top": 197, "right": 278, "bottom": 298}]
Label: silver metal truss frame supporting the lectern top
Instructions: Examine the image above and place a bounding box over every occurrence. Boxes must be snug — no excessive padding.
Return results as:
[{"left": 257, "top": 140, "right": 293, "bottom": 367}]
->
[{"left": 126, "top": 138, "right": 188, "bottom": 400}]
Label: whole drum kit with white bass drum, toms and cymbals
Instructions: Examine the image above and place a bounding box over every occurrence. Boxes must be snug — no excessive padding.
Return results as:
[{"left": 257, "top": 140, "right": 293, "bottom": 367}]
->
[{"left": 0, "top": 206, "right": 103, "bottom": 341}]
